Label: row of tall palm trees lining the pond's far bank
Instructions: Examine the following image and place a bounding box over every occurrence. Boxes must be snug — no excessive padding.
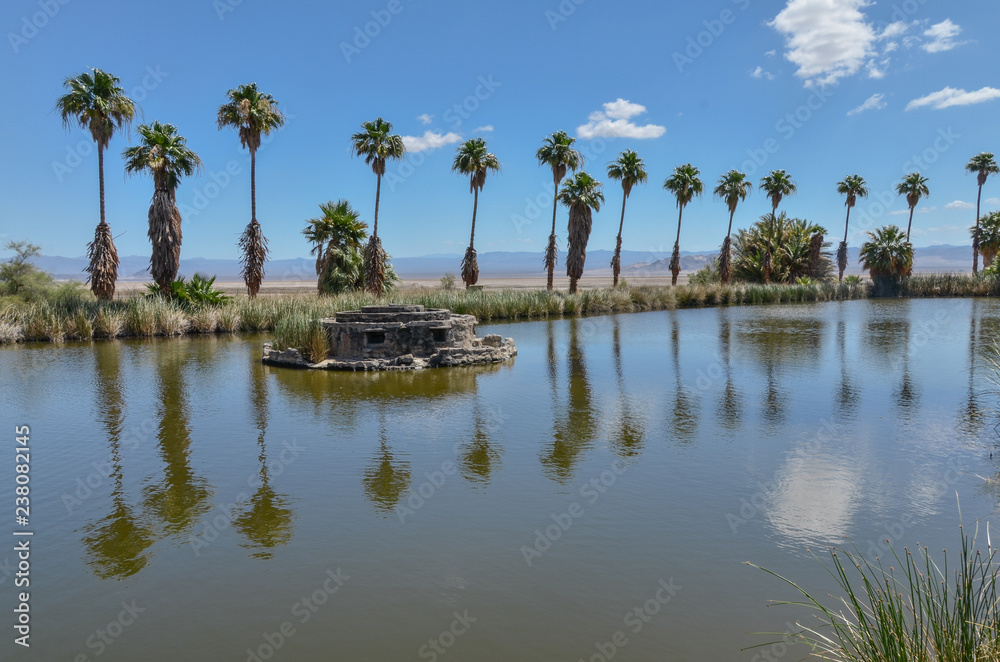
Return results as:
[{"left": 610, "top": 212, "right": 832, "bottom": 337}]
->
[{"left": 56, "top": 69, "right": 1000, "bottom": 299}]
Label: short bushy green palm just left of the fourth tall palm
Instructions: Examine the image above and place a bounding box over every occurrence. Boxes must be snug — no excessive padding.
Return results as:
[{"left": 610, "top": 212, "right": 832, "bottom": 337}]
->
[{"left": 302, "top": 200, "right": 368, "bottom": 294}]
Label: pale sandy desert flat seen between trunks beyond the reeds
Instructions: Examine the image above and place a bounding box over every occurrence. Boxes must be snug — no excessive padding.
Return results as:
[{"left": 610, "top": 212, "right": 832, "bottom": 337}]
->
[{"left": 118, "top": 274, "right": 688, "bottom": 296}]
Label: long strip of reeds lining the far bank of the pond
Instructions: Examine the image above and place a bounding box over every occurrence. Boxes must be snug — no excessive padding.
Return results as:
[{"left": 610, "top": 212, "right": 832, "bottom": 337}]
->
[{"left": 0, "top": 275, "right": 1000, "bottom": 351}]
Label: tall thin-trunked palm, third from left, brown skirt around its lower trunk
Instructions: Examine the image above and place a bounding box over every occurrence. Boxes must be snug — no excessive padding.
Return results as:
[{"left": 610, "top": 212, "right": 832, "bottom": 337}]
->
[{"left": 218, "top": 83, "right": 285, "bottom": 299}]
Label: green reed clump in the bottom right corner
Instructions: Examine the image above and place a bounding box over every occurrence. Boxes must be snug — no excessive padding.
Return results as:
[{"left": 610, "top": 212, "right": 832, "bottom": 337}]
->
[{"left": 750, "top": 527, "right": 1000, "bottom": 662}]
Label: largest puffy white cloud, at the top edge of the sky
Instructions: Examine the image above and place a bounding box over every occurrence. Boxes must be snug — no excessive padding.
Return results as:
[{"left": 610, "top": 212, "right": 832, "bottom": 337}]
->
[{"left": 768, "top": 0, "right": 878, "bottom": 86}]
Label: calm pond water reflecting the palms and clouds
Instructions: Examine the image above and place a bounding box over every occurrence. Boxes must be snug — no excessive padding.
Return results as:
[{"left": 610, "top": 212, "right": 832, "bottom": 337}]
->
[{"left": 0, "top": 300, "right": 1000, "bottom": 662}]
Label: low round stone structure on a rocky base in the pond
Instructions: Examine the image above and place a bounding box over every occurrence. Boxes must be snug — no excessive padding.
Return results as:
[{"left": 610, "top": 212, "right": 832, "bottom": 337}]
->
[{"left": 263, "top": 304, "right": 517, "bottom": 370}]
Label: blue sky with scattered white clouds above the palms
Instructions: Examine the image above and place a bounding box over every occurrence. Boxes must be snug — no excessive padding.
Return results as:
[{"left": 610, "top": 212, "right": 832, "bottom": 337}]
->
[{"left": 0, "top": 0, "right": 1000, "bottom": 264}]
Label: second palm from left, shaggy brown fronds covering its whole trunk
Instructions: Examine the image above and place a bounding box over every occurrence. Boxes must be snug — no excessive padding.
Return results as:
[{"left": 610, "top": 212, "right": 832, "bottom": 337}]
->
[{"left": 122, "top": 121, "right": 202, "bottom": 294}]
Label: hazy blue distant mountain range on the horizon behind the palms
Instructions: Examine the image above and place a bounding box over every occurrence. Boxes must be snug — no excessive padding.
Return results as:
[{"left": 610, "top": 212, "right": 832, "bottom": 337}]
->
[{"left": 34, "top": 245, "right": 972, "bottom": 281}]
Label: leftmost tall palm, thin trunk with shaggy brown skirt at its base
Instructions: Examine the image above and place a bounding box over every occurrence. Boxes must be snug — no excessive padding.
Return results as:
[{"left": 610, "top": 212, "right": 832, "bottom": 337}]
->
[{"left": 56, "top": 68, "right": 135, "bottom": 299}]
